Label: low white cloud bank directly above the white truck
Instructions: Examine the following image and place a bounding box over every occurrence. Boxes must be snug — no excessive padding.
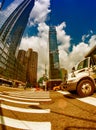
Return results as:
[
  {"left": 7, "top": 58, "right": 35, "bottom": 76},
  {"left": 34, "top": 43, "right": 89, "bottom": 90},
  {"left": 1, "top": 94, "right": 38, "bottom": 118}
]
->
[{"left": 60, "top": 35, "right": 96, "bottom": 72}]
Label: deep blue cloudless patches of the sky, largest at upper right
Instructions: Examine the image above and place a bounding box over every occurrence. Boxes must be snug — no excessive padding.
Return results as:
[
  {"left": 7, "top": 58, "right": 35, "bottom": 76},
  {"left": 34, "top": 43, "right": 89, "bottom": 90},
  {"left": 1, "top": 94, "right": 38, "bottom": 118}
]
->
[{"left": 0, "top": 0, "right": 96, "bottom": 44}]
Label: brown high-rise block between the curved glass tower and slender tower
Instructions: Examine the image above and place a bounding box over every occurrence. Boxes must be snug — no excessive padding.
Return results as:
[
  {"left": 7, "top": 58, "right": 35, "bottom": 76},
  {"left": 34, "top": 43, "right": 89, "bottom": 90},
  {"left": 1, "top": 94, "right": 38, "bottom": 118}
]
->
[{"left": 17, "top": 48, "right": 38, "bottom": 86}]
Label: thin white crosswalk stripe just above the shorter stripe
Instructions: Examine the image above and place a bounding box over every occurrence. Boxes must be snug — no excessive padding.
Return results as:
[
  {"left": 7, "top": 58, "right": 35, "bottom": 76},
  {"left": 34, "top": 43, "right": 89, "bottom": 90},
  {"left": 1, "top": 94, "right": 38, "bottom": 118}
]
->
[{"left": 0, "top": 95, "right": 52, "bottom": 101}]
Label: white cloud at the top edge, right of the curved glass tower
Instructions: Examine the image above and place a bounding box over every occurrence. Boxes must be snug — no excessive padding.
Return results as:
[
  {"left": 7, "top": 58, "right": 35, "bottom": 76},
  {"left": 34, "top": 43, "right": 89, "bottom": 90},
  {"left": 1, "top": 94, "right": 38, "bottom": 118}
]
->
[{"left": 29, "top": 0, "right": 50, "bottom": 25}]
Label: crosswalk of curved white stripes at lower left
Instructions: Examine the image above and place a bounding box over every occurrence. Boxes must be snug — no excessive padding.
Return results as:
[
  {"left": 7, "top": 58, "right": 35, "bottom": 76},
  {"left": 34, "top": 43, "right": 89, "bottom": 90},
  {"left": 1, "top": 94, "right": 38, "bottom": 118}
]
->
[{"left": 0, "top": 91, "right": 51, "bottom": 130}]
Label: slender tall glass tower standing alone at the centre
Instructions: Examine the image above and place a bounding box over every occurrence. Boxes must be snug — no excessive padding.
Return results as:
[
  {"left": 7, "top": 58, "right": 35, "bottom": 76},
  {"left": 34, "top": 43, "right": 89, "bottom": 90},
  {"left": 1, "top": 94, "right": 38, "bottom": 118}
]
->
[{"left": 49, "top": 26, "right": 60, "bottom": 79}]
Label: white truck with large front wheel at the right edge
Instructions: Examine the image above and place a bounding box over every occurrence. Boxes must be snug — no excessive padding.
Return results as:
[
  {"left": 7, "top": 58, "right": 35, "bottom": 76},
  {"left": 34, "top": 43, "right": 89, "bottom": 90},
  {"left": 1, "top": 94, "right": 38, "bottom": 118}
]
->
[{"left": 62, "top": 50, "right": 96, "bottom": 97}]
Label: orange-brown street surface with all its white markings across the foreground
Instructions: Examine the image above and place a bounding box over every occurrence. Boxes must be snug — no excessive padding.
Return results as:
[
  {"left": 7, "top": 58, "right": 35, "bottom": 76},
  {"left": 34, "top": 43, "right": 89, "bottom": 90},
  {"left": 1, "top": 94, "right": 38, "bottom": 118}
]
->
[{"left": 0, "top": 87, "right": 96, "bottom": 130}]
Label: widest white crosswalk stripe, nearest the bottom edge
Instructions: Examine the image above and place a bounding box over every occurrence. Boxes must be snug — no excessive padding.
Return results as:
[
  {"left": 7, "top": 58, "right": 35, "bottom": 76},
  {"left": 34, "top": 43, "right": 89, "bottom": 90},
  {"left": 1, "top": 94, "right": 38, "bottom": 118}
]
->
[{"left": 0, "top": 116, "right": 51, "bottom": 130}]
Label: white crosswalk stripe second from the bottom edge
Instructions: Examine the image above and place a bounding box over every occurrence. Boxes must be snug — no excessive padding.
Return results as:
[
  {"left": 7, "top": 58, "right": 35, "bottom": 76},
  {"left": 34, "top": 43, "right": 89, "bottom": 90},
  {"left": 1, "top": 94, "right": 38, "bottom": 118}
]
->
[{"left": 0, "top": 104, "right": 50, "bottom": 113}]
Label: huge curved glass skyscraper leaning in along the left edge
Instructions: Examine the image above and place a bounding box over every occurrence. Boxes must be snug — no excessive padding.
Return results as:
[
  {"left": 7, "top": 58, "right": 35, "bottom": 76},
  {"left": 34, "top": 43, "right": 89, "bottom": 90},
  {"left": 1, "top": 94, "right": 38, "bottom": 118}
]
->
[{"left": 0, "top": 0, "right": 35, "bottom": 80}]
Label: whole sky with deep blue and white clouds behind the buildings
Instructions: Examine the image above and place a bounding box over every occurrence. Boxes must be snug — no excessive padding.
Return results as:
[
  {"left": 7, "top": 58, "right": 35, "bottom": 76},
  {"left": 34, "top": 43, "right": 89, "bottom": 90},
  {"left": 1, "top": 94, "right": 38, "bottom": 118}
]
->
[{"left": 0, "top": 0, "right": 96, "bottom": 75}]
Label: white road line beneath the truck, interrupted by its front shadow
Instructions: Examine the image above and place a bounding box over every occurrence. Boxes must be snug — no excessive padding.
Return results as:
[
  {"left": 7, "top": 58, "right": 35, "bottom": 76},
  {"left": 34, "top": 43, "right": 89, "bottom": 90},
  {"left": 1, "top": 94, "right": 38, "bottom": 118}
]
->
[{"left": 58, "top": 91, "right": 96, "bottom": 106}]
